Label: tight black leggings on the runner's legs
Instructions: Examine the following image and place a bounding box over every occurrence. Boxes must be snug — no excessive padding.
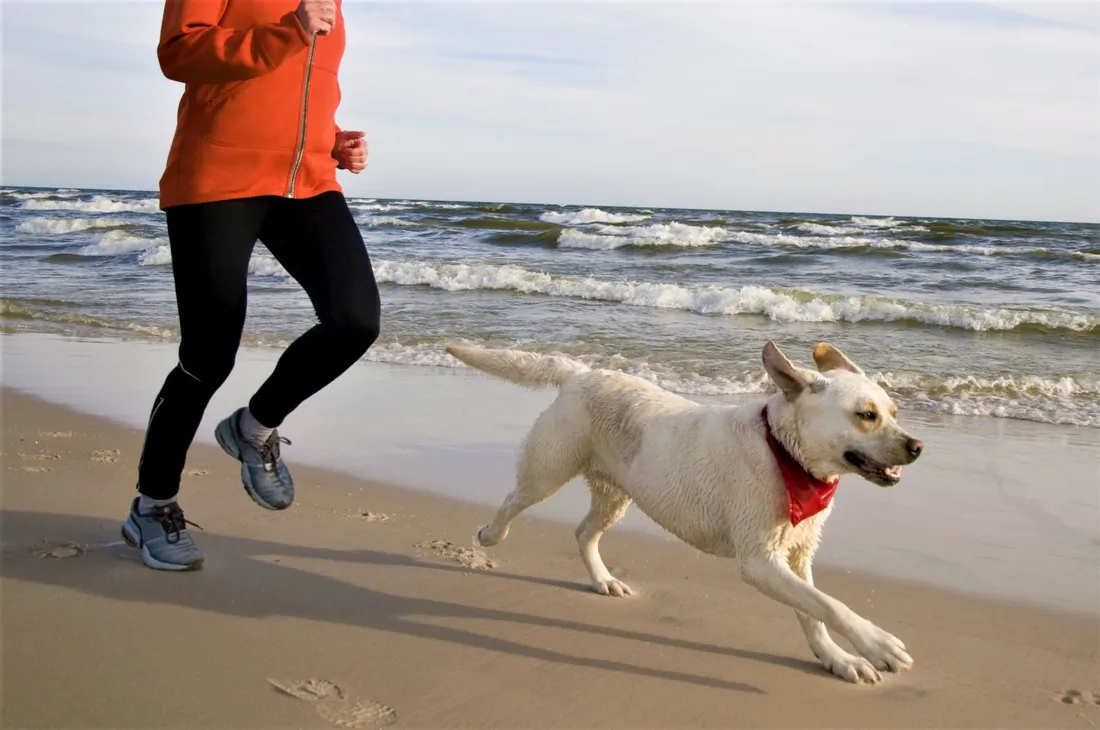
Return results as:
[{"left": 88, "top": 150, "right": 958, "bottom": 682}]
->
[{"left": 138, "top": 192, "right": 381, "bottom": 499}]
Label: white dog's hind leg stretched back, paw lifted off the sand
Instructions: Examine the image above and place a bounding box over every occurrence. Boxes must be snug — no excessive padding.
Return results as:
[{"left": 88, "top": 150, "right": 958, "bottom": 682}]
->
[{"left": 477, "top": 400, "right": 589, "bottom": 548}]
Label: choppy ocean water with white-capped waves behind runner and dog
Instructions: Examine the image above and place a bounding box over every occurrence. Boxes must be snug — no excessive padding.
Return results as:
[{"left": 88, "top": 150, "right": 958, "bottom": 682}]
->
[{"left": 0, "top": 188, "right": 1100, "bottom": 428}]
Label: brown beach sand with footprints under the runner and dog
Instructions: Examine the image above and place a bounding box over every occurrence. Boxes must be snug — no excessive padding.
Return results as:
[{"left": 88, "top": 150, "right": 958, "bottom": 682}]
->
[{"left": 0, "top": 389, "right": 1100, "bottom": 728}]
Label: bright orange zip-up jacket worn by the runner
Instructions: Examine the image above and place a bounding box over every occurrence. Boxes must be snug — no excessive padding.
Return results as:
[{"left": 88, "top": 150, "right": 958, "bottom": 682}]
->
[{"left": 156, "top": 0, "right": 344, "bottom": 208}]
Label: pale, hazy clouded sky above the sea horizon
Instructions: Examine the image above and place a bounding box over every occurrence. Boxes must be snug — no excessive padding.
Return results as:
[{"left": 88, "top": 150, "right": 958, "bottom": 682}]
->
[{"left": 0, "top": 0, "right": 1100, "bottom": 222}]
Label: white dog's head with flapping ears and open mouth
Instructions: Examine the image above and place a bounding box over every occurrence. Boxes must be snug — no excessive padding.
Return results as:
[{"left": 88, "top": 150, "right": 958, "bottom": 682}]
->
[{"left": 763, "top": 342, "right": 924, "bottom": 487}]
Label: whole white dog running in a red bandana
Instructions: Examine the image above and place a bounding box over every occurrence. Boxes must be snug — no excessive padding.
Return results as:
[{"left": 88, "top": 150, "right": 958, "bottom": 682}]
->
[{"left": 447, "top": 342, "right": 923, "bottom": 683}]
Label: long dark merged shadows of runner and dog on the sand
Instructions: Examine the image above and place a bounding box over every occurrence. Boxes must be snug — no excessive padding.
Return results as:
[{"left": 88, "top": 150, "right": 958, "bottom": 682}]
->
[{"left": 0, "top": 510, "right": 822, "bottom": 694}]
